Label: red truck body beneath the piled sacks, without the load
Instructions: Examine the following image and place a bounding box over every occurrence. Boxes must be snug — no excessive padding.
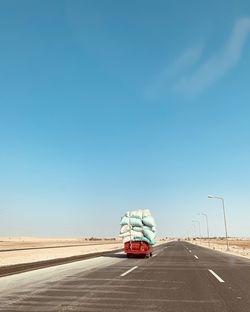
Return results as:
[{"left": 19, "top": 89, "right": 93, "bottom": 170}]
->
[{"left": 124, "top": 241, "right": 153, "bottom": 258}]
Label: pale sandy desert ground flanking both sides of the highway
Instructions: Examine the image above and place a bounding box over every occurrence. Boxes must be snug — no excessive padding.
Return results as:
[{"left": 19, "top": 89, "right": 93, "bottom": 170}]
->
[{"left": 0, "top": 237, "right": 250, "bottom": 267}]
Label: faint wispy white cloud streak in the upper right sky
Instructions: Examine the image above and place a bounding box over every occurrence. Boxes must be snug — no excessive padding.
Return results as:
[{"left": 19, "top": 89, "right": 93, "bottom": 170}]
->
[{"left": 147, "top": 17, "right": 250, "bottom": 96}]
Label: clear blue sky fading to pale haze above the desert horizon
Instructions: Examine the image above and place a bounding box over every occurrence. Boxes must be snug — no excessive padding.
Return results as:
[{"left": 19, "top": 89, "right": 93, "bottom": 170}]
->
[{"left": 0, "top": 0, "right": 250, "bottom": 237}]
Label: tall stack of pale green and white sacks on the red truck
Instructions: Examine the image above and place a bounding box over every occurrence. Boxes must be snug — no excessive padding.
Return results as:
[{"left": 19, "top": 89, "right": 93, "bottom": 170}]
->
[{"left": 119, "top": 209, "right": 155, "bottom": 245}]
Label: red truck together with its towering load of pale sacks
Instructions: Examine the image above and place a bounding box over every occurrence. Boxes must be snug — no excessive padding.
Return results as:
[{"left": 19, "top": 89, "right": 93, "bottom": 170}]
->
[{"left": 119, "top": 209, "right": 155, "bottom": 257}]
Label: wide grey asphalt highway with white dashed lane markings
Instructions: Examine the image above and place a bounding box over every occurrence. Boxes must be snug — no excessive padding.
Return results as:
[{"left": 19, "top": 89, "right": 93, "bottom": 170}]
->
[{"left": 0, "top": 242, "right": 250, "bottom": 312}]
